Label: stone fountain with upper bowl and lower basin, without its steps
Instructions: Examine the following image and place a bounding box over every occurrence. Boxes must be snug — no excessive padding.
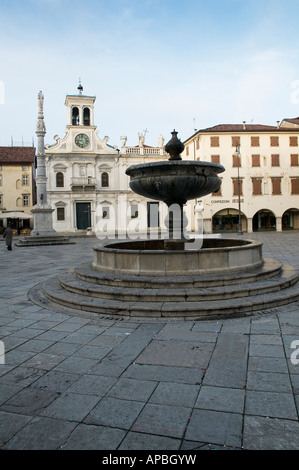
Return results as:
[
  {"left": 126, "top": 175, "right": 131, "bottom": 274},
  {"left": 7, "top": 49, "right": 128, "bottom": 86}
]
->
[{"left": 93, "top": 130, "right": 263, "bottom": 276}]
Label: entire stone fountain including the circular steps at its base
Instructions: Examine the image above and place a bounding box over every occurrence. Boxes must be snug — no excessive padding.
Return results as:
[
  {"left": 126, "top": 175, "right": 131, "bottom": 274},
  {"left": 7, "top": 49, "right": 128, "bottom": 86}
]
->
[{"left": 34, "top": 131, "right": 299, "bottom": 321}]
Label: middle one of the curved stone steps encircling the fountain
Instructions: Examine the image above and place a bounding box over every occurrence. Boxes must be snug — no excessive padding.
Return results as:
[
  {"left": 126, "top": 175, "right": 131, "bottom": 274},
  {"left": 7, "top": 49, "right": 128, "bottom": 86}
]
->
[{"left": 59, "top": 265, "right": 298, "bottom": 302}]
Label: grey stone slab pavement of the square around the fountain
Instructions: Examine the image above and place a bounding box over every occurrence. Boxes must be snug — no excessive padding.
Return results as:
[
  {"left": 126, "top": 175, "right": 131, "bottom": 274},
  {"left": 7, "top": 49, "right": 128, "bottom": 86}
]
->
[{"left": 0, "top": 231, "right": 299, "bottom": 451}]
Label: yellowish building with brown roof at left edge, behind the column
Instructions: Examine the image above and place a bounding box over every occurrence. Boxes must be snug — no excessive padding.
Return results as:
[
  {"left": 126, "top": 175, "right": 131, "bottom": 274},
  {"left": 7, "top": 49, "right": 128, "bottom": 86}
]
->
[{"left": 0, "top": 147, "right": 36, "bottom": 233}]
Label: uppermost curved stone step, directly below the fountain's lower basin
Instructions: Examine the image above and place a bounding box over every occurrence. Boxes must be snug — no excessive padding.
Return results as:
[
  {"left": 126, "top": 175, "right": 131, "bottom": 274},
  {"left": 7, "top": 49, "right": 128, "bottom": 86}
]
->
[{"left": 75, "top": 258, "right": 282, "bottom": 289}]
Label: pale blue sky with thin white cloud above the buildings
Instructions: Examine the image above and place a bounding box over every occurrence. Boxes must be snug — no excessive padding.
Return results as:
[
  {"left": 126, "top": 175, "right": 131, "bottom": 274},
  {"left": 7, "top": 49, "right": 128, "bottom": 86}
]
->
[{"left": 0, "top": 0, "right": 299, "bottom": 148}]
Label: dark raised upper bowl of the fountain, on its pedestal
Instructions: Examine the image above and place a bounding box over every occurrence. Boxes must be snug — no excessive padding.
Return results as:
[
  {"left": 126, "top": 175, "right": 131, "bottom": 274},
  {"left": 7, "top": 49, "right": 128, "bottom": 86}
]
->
[{"left": 126, "top": 160, "right": 225, "bottom": 205}]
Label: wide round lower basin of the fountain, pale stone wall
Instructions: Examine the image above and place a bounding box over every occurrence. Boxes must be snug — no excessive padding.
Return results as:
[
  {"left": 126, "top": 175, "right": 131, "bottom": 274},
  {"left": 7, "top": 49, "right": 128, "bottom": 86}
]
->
[{"left": 92, "top": 238, "right": 263, "bottom": 277}]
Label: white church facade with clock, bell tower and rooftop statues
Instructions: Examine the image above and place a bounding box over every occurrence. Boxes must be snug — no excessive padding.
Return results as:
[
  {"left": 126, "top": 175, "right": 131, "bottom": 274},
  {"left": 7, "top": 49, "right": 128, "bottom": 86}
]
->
[{"left": 45, "top": 85, "right": 169, "bottom": 237}]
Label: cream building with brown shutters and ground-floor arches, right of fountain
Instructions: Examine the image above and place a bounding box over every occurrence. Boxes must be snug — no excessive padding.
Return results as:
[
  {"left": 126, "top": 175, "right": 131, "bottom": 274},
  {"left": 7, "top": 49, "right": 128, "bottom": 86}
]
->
[{"left": 182, "top": 118, "right": 299, "bottom": 233}]
